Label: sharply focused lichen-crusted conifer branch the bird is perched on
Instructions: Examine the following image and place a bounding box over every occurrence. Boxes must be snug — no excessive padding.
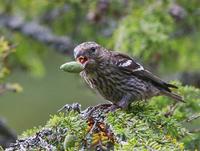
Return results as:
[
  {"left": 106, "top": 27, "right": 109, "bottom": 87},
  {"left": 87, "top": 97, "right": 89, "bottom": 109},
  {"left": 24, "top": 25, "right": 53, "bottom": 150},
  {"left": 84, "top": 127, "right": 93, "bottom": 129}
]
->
[{"left": 6, "top": 103, "right": 189, "bottom": 151}]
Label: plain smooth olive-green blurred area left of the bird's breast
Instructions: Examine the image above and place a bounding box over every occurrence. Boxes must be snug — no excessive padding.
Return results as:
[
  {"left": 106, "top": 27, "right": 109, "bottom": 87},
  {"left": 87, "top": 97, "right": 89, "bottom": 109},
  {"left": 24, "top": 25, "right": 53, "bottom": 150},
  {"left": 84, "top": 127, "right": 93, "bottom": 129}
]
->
[{"left": 0, "top": 51, "right": 103, "bottom": 134}]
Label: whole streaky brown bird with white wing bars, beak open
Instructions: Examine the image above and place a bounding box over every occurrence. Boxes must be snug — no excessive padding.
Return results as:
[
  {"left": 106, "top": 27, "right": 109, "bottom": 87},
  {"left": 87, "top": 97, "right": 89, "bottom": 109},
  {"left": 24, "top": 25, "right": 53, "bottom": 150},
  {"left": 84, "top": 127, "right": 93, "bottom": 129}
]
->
[{"left": 74, "top": 41, "right": 184, "bottom": 109}]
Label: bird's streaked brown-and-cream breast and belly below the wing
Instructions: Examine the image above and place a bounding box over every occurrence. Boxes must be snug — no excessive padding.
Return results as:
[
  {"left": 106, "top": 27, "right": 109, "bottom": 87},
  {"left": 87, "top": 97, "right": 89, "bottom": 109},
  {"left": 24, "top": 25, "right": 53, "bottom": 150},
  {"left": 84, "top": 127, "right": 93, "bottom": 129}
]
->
[{"left": 81, "top": 61, "right": 159, "bottom": 102}]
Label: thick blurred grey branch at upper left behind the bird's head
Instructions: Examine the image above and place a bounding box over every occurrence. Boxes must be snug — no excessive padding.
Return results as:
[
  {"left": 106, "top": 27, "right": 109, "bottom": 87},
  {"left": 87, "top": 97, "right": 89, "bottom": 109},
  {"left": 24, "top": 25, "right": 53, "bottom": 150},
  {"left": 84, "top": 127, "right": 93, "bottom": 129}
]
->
[{"left": 0, "top": 14, "right": 74, "bottom": 54}]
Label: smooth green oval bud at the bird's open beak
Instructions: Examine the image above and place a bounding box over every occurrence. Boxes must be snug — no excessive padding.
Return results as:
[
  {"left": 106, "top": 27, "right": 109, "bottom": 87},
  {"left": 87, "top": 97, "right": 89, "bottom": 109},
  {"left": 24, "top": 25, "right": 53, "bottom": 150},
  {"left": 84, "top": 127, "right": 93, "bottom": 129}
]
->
[{"left": 60, "top": 61, "right": 84, "bottom": 73}]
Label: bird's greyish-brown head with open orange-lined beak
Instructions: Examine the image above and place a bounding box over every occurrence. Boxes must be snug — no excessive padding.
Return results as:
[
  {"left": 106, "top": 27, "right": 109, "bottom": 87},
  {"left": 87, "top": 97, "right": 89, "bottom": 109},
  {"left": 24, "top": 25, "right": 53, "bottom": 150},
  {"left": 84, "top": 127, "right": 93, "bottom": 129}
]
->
[{"left": 74, "top": 42, "right": 104, "bottom": 69}]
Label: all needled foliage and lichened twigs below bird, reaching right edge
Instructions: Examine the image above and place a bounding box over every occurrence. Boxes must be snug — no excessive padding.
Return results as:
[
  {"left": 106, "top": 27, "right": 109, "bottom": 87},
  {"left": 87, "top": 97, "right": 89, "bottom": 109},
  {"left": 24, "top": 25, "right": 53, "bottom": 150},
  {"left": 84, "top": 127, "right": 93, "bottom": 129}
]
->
[{"left": 3, "top": 83, "right": 200, "bottom": 151}]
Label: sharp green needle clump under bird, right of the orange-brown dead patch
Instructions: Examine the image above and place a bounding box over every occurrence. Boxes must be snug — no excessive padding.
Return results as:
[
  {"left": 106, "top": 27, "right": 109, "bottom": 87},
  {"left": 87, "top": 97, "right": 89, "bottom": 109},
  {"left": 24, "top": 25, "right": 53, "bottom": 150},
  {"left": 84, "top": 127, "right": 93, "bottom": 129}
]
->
[{"left": 107, "top": 105, "right": 186, "bottom": 150}]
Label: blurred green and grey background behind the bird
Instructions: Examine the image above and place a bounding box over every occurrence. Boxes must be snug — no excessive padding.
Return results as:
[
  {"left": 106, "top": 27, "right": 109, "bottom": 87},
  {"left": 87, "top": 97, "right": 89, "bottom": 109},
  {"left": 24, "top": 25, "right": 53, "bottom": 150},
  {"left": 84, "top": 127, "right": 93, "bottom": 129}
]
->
[{"left": 0, "top": 0, "right": 200, "bottom": 137}]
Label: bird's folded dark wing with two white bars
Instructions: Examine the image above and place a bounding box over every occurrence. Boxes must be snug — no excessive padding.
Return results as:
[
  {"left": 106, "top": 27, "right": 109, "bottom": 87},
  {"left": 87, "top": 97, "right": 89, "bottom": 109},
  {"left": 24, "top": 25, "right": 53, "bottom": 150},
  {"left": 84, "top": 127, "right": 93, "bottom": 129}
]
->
[{"left": 112, "top": 52, "right": 177, "bottom": 92}]
